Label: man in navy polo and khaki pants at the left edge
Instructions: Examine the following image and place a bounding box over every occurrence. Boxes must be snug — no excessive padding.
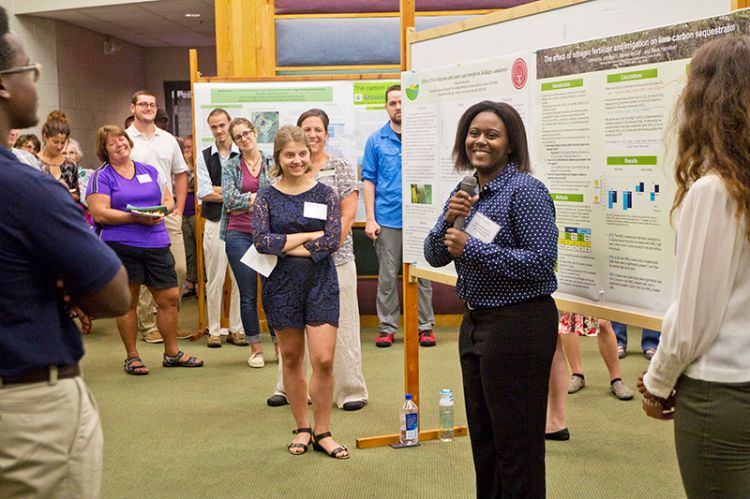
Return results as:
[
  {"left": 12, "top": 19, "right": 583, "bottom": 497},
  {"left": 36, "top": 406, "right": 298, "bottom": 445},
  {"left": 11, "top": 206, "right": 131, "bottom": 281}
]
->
[{"left": 0, "top": 7, "right": 130, "bottom": 498}]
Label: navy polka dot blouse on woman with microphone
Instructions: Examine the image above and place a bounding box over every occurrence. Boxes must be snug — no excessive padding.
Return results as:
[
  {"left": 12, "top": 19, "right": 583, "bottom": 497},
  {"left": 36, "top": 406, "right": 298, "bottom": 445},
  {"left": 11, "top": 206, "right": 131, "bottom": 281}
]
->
[{"left": 424, "top": 162, "right": 558, "bottom": 308}]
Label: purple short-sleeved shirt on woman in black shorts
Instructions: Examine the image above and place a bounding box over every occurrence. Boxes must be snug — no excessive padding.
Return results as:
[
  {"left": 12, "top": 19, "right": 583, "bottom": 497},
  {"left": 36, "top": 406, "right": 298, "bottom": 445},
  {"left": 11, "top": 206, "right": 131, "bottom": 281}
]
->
[{"left": 86, "top": 161, "right": 169, "bottom": 248}]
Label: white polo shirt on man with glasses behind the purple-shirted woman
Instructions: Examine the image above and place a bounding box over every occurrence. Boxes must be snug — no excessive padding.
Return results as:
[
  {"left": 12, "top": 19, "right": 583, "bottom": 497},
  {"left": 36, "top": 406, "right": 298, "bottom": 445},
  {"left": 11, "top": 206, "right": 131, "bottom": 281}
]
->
[{"left": 125, "top": 125, "right": 188, "bottom": 194}]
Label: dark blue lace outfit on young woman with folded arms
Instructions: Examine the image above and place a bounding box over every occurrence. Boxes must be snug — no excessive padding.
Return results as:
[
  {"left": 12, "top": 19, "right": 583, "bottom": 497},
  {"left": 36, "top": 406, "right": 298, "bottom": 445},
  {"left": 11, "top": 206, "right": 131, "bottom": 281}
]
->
[{"left": 253, "top": 183, "right": 341, "bottom": 329}]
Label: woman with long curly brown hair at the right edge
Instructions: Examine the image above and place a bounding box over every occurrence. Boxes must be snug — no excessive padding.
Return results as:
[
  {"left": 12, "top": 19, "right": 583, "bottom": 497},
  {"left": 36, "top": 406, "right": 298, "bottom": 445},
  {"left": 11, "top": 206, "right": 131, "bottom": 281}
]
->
[{"left": 639, "top": 36, "right": 750, "bottom": 498}]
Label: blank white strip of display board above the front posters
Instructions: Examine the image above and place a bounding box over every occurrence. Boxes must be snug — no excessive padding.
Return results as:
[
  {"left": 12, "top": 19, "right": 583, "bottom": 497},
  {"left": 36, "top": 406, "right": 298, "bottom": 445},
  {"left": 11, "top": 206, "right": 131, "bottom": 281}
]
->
[{"left": 411, "top": 0, "right": 732, "bottom": 70}]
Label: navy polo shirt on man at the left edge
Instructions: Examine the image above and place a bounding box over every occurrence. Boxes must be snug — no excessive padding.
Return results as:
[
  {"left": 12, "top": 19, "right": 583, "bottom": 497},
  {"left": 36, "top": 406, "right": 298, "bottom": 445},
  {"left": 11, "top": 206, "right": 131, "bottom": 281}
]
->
[{"left": 0, "top": 147, "right": 121, "bottom": 376}]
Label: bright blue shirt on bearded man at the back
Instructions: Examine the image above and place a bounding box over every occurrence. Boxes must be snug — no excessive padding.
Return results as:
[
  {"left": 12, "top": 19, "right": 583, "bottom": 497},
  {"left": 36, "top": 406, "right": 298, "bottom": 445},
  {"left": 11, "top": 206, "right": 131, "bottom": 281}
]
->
[{"left": 362, "top": 122, "right": 402, "bottom": 229}]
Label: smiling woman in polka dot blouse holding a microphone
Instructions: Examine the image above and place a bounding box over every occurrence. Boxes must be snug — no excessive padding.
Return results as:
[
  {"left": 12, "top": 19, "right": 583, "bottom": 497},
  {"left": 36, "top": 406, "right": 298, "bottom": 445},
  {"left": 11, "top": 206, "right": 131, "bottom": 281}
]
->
[{"left": 424, "top": 101, "right": 558, "bottom": 498}]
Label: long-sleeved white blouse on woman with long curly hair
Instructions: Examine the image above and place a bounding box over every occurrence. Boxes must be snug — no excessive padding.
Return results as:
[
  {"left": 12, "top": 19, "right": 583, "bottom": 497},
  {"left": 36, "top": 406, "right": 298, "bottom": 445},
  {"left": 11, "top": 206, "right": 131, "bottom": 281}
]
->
[{"left": 644, "top": 174, "right": 750, "bottom": 398}]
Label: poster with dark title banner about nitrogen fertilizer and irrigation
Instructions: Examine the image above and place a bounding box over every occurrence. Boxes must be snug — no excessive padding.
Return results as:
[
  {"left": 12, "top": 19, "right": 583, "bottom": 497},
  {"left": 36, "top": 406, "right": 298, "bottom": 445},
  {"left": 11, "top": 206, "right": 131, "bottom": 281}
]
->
[{"left": 535, "top": 12, "right": 747, "bottom": 313}]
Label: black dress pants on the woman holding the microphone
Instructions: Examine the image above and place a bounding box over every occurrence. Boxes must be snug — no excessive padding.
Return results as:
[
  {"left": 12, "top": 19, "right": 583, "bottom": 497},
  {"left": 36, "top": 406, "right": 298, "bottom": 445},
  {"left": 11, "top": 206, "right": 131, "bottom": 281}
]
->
[{"left": 459, "top": 296, "right": 557, "bottom": 499}]
